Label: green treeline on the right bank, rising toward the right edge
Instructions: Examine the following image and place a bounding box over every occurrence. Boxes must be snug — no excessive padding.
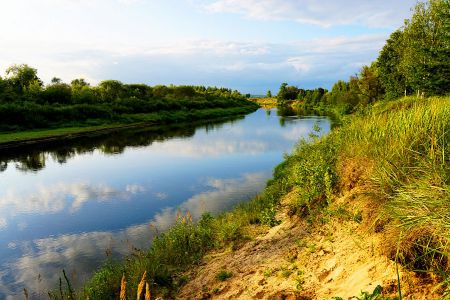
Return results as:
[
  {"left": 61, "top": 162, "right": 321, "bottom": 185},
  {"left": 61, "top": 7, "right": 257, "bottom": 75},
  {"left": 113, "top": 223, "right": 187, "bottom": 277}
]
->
[{"left": 277, "top": 0, "right": 450, "bottom": 113}]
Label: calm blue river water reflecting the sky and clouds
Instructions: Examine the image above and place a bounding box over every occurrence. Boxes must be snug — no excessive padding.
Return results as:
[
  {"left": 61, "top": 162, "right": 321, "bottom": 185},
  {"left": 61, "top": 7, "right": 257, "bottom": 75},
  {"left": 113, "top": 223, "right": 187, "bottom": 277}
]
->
[{"left": 0, "top": 109, "right": 330, "bottom": 299}]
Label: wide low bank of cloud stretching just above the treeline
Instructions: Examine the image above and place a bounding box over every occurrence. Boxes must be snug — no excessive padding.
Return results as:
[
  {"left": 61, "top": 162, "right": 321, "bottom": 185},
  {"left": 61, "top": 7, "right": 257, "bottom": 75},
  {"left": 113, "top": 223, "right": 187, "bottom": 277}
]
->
[{"left": 0, "top": 27, "right": 387, "bottom": 93}]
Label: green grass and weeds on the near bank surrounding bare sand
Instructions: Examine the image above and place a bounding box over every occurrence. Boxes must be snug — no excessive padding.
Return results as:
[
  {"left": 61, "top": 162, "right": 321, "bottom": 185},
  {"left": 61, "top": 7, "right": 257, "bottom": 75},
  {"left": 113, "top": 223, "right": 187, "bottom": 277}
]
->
[{"left": 56, "top": 97, "right": 450, "bottom": 299}]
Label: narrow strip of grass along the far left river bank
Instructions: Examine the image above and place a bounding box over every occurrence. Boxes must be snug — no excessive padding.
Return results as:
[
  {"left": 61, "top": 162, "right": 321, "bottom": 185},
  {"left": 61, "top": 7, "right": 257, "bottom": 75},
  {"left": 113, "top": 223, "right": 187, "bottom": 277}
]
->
[{"left": 0, "top": 105, "right": 257, "bottom": 149}]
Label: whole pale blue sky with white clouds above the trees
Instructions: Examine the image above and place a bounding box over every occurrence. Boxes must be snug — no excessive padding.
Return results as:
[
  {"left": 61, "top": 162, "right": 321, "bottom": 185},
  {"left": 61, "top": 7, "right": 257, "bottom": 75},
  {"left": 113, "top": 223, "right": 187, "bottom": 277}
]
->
[{"left": 0, "top": 0, "right": 416, "bottom": 93}]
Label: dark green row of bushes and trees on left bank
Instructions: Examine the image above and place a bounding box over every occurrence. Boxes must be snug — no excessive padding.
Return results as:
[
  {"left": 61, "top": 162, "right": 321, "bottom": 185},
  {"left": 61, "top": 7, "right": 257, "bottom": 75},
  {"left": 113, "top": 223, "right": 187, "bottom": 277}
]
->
[{"left": 0, "top": 69, "right": 254, "bottom": 131}]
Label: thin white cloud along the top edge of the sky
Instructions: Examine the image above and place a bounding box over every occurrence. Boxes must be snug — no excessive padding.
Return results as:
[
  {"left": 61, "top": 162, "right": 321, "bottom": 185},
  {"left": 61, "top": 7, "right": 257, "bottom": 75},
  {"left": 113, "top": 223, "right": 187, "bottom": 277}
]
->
[{"left": 203, "top": 0, "right": 415, "bottom": 27}]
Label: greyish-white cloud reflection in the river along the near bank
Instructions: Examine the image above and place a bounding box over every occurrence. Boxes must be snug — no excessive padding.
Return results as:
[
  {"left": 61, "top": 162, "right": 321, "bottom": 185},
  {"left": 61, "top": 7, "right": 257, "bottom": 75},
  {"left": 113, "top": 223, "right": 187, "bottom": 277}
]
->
[{"left": 0, "top": 172, "right": 270, "bottom": 296}]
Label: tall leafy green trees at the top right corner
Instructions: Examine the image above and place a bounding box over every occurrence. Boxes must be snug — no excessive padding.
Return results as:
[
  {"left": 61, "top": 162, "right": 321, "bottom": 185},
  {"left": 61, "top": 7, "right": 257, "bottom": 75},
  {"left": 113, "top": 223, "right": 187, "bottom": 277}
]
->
[{"left": 378, "top": 0, "right": 450, "bottom": 99}]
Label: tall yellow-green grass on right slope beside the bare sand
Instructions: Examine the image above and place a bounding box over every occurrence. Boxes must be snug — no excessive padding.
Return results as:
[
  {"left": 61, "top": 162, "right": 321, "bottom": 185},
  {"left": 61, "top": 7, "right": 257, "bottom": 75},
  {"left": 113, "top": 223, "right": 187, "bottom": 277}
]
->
[{"left": 336, "top": 97, "right": 450, "bottom": 274}]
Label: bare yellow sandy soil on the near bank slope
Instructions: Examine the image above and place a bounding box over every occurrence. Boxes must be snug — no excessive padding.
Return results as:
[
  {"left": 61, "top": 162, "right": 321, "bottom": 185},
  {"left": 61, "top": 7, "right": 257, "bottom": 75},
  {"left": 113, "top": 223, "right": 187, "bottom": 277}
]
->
[{"left": 177, "top": 186, "right": 439, "bottom": 299}]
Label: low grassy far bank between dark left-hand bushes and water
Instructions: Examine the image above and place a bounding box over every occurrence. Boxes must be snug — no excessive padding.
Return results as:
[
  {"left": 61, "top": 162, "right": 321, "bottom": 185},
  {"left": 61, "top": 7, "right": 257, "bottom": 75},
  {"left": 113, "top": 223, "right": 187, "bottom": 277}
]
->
[{"left": 0, "top": 106, "right": 259, "bottom": 152}]
